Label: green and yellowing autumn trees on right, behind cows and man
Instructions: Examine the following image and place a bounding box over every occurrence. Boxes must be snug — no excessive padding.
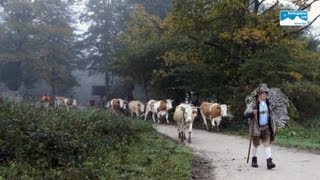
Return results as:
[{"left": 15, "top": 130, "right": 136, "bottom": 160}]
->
[{"left": 112, "top": 0, "right": 320, "bottom": 118}]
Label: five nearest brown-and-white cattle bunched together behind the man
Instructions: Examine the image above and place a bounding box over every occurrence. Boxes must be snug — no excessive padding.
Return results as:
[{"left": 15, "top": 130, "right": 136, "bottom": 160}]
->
[{"left": 106, "top": 99, "right": 230, "bottom": 143}]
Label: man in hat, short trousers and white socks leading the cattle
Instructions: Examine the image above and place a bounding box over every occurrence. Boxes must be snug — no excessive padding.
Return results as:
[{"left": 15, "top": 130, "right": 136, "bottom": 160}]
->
[{"left": 244, "top": 87, "right": 276, "bottom": 169}]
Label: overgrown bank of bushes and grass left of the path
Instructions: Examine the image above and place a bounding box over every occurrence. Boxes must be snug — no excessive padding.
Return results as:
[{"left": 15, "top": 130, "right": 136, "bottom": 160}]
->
[{"left": 0, "top": 104, "right": 193, "bottom": 179}]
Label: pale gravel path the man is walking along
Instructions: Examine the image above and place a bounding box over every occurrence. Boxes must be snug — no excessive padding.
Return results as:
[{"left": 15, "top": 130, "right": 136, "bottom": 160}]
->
[{"left": 156, "top": 125, "right": 320, "bottom": 180}]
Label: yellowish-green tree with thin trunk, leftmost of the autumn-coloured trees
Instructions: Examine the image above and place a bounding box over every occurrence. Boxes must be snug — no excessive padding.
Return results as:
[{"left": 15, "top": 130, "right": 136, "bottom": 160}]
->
[{"left": 111, "top": 5, "right": 164, "bottom": 99}]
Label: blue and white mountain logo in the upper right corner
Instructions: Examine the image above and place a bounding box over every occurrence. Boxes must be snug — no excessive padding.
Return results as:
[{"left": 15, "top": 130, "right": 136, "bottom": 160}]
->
[{"left": 279, "top": 11, "right": 308, "bottom": 26}]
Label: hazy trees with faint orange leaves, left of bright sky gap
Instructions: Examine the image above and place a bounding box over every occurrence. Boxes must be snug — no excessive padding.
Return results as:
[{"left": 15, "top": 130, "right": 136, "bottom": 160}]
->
[{"left": 0, "top": 0, "right": 76, "bottom": 94}]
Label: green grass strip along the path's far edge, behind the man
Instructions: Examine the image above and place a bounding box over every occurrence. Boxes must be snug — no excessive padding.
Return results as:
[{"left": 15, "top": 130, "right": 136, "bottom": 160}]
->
[{"left": 223, "top": 117, "right": 320, "bottom": 153}]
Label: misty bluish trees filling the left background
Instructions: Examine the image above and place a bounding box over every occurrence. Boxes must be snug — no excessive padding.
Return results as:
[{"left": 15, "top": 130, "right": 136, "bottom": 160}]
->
[{"left": 0, "top": 0, "right": 171, "bottom": 94}]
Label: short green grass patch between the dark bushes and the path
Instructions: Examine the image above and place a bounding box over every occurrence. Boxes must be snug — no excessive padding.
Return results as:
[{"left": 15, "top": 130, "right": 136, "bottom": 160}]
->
[{"left": 119, "top": 132, "right": 193, "bottom": 179}]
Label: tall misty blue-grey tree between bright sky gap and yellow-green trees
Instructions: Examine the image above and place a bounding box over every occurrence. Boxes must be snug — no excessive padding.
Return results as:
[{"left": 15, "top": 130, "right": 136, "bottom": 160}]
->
[{"left": 83, "top": 0, "right": 171, "bottom": 99}]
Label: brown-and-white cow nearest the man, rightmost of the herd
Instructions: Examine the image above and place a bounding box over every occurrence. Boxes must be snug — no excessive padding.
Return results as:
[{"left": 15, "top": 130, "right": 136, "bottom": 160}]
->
[{"left": 200, "top": 102, "right": 228, "bottom": 132}]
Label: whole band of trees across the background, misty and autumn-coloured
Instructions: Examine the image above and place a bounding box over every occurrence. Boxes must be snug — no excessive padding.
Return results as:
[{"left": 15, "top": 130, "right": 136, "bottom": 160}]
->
[{"left": 0, "top": 0, "right": 320, "bottom": 117}]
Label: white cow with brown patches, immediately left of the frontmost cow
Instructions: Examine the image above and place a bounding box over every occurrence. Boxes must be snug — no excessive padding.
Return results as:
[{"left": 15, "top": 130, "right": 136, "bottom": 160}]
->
[{"left": 144, "top": 99, "right": 173, "bottom": 124}]
